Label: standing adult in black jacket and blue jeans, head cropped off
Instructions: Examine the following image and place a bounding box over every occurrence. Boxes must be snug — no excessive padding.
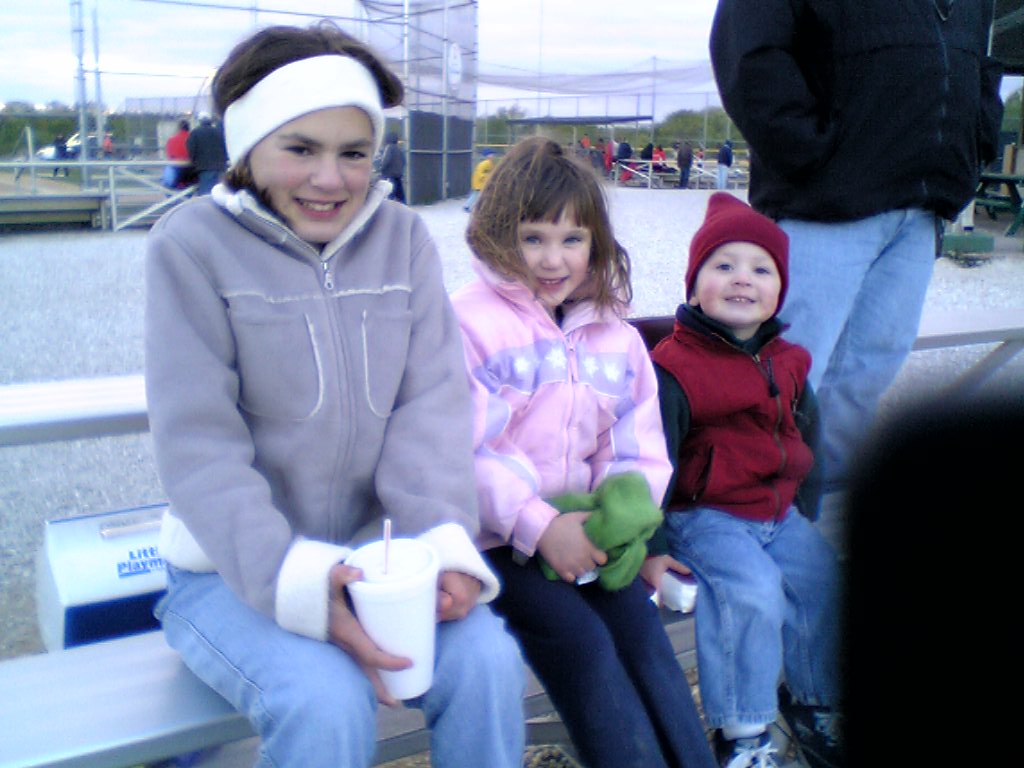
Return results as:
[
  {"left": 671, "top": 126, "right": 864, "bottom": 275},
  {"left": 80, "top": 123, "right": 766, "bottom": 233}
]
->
[{"left": 711, "top": 0, "right": 1001, "bottom": 499}]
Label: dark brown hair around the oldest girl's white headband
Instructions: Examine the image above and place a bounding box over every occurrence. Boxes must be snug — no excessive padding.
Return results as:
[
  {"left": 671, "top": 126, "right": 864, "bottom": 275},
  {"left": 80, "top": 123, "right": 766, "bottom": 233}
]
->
[{"left": 211, "top": 19, "right": 404, "bottom": 189}]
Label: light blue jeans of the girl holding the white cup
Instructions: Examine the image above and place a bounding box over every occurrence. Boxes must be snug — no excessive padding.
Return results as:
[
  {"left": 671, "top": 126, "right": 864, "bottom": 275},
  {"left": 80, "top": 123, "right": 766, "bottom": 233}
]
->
[{"left": 157, "top": 568, "right": 525, "bottom": 768}]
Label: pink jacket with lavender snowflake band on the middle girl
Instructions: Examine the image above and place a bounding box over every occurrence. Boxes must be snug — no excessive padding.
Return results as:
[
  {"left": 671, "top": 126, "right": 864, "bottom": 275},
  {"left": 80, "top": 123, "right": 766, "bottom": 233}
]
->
[{"left": 452, "top": 261, "right": 672, "bottom": 556}]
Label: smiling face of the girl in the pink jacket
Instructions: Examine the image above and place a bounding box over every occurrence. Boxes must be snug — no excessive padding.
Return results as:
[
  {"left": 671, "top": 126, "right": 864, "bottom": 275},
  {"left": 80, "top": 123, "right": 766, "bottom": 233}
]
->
[{"left": 519, "top": 210, "right": 591, "bottom": 315}]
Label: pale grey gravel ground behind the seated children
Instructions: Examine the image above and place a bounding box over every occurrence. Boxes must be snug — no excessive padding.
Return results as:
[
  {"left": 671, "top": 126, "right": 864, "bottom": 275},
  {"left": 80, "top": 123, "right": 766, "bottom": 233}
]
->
[{"left": 0, "top": 188, "right": 1024, "bottom": 658}]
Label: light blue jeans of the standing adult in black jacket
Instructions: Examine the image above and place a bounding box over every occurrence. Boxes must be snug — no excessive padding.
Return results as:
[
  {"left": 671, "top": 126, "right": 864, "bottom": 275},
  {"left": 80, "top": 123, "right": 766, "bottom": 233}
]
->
[{"left": 778, "top": 209, "right": 936, "bottom": 484}]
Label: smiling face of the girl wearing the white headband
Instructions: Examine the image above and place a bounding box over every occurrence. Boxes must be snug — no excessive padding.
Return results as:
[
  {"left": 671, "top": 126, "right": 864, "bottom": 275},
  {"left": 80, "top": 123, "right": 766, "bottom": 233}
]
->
[{"left": 249, "top": 106, "right": 374, "bottom": 246}]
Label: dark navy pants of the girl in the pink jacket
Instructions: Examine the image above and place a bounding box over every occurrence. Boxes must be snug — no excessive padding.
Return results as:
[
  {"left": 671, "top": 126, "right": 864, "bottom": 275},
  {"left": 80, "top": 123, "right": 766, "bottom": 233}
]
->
[{"left": 484, "top": 547, "right": 715, "bottom": 768}]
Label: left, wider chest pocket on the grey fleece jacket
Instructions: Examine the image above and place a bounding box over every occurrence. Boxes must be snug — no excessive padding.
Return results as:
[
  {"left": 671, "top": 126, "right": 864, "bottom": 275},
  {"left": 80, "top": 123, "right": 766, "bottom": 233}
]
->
[{"left": 232, "top": 313, "right": 324, "bottom": 421}]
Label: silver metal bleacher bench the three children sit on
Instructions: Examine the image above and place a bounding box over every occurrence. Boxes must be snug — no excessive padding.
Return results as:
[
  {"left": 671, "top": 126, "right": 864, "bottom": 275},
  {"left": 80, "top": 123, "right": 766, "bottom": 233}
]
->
[{"left": 0, "top": 611, "right": 695, "bottom": 768}]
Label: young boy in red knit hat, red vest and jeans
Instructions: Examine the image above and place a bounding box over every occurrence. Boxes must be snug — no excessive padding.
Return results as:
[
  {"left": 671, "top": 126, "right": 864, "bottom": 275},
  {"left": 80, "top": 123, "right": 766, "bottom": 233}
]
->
[{"left": 651, "top": 193, "right": 841, "bottom": 768}]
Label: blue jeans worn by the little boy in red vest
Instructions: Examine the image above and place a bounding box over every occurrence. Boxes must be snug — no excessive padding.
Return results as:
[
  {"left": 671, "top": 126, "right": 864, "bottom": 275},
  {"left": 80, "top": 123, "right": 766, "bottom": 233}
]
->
[{"left": 666, "top": 507, "right": 841, "bottom": 728}]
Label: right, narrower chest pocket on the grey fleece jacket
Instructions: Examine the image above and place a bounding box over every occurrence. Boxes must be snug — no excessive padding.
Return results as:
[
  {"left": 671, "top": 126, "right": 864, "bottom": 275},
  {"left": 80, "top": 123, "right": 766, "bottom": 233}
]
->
[{"left": 362, "top": 310, "right": 413, "bottom": 419}]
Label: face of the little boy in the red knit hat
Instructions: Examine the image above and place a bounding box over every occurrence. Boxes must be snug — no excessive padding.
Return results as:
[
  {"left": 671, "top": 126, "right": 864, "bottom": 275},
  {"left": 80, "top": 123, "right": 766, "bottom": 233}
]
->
[{"left": 690, "top": 242, "right": 782, "bottom": 340}]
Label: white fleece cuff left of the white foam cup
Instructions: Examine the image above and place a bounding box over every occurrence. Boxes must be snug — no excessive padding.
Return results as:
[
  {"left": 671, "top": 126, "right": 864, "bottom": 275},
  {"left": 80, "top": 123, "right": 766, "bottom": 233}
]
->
[{"left": 274, "top": 539, "right": 351, "bottom": 640}]
